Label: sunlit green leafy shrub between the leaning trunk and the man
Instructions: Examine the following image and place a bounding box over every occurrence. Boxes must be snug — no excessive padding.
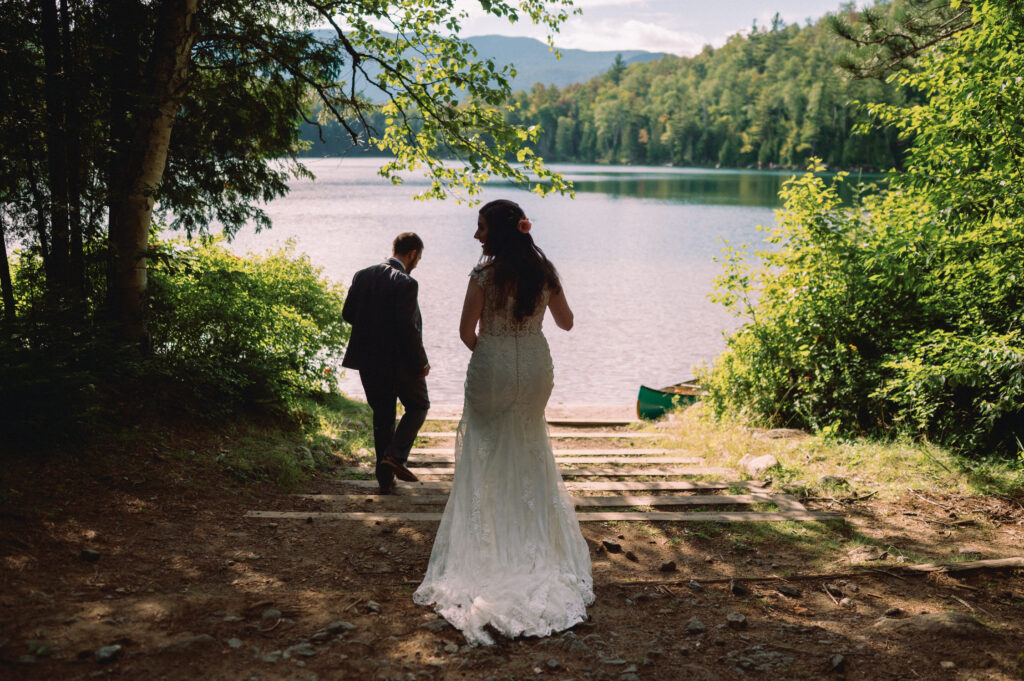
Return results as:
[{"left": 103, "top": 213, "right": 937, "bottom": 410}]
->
[{"left": 150, "top": 240, "right": 348, "bottom": 413}]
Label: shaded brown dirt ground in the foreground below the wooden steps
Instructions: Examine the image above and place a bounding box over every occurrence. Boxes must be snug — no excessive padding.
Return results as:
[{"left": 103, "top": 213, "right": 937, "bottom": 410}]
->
[{"left": 0, "top": 417, "right": 1024, "bottom": 681}]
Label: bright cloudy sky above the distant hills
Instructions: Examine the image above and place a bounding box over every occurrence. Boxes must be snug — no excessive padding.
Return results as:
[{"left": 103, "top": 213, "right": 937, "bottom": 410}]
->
[{"left": 458, "top": 0, "right": 865, "bottom": 56}]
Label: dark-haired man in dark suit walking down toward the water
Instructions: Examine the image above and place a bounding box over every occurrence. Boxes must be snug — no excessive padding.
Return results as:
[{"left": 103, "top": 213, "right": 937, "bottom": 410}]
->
[{"left": 341, "top": 231, "right": 430, "bottom": 495}]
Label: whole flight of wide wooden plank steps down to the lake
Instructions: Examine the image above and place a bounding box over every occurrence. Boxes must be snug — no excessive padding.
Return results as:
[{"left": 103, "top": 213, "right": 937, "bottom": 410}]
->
[{"left": 246, "top": 409, "right": 843, "bottom": 522}]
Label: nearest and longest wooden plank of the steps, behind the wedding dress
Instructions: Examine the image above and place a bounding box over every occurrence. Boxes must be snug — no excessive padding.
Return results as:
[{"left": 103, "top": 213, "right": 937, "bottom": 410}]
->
[{"left": 245, "top": 511, "right": 843, "bottom": 522}]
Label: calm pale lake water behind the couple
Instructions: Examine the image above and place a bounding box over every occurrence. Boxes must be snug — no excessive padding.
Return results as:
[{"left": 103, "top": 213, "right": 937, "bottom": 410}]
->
[{"left": 231, "top": 158, "right": 806, "bottom": 405}]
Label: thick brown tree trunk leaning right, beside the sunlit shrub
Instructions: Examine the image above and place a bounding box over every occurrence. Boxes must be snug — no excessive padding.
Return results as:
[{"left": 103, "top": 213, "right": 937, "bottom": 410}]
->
[{"left": 110, "top": 0, "right": 199, "bottom": 346}]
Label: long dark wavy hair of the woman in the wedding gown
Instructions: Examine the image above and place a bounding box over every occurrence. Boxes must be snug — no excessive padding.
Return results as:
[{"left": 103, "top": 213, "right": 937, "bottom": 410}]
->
[{"left": 480, "top": 199, "right": 562, "bottom": 321}]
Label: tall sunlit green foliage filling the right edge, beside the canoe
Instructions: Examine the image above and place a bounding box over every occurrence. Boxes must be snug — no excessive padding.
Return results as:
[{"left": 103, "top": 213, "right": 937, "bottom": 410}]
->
[{"left": 703, "top": 2, "right": 1024, "bottom": 456}]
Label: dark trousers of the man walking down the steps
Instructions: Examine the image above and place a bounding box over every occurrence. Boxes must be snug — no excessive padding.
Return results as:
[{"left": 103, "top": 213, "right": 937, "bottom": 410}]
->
[{"left": 359, "top": 369, "right": 430, "bottom": 490}]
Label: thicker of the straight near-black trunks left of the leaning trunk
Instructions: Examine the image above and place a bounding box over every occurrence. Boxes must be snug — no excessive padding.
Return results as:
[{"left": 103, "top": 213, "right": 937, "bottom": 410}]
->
[{"left": 41, "top": 0, "right": 71, "bottom": 299}]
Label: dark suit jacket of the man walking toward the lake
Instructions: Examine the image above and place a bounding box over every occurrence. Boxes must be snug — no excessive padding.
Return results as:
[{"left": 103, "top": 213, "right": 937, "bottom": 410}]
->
[{"left": 341, "top": 258, "right": 427, "bottom": 374}]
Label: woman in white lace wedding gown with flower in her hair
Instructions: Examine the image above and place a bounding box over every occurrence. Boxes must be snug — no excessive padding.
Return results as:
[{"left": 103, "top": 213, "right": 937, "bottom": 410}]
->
[{"left": 413, "top": 200, "right": 594, "bottom": 644}]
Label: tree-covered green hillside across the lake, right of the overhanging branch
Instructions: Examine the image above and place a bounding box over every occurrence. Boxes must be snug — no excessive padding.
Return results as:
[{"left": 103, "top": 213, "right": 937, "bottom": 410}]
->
[{"left": 511, "top": 10, "right": 907, "bottom": 169}]
